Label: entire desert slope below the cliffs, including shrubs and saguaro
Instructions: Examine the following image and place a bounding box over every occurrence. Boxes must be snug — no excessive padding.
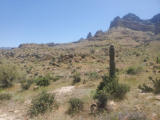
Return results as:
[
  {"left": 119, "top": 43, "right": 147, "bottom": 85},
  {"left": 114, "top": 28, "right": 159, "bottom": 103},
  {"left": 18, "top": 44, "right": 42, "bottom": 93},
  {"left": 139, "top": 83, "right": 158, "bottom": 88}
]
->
[{"left": 0, "top": 13, "right": 160, "bottom": 120}]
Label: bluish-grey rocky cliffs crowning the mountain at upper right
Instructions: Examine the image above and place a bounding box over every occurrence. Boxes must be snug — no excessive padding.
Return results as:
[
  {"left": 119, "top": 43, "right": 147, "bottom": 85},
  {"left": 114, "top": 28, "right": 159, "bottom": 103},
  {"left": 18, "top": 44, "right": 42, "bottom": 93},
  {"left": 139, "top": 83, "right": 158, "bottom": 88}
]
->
[{"left": 110, "top": 13, "right": 160, "bottom": 34}]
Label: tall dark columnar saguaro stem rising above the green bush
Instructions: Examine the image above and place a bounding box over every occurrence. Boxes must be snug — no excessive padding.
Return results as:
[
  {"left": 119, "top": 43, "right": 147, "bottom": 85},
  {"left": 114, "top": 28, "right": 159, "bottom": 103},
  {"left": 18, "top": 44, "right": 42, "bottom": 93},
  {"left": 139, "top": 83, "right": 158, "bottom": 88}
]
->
[{"left": 109, "top": 45, "right": 116, "bottom": 78}]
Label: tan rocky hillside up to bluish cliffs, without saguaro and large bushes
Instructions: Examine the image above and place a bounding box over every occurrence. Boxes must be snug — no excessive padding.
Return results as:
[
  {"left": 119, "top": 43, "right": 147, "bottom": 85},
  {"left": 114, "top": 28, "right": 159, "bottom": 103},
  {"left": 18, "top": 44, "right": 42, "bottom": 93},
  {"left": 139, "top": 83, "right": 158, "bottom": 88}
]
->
[{"left": 0, "top": 14, "right": 160, "bottom": 120}]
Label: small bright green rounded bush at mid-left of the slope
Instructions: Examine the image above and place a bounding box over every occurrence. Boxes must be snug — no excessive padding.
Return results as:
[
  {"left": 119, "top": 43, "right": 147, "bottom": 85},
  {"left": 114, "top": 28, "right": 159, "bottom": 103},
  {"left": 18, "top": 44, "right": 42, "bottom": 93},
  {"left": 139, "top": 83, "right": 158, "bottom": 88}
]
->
[{"left": 35, "top": 76, "right": 50, "bottom": 86}]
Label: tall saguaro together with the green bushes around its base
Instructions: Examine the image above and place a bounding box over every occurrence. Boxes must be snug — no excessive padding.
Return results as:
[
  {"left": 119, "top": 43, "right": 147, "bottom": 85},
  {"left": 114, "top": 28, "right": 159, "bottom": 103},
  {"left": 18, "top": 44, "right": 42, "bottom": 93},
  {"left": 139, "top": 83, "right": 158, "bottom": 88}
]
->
[{"left": 94, "top": 45, "right": 129, "bottom": 109}]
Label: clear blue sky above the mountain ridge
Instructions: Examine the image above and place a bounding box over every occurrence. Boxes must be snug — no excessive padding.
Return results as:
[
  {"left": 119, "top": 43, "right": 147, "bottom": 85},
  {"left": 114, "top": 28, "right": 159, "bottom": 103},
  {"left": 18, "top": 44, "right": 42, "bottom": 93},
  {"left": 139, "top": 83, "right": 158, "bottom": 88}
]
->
[{"left": 0, "top": 0, "right": 160, "bottom": 47}]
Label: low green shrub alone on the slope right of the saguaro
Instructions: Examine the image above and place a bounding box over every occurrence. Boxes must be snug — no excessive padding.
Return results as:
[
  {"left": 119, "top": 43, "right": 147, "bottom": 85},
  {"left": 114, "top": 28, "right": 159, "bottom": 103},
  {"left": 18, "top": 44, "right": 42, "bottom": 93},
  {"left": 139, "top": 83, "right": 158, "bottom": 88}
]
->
[{"left": 127, "top": 67, "right": 142, "bottom": 75}]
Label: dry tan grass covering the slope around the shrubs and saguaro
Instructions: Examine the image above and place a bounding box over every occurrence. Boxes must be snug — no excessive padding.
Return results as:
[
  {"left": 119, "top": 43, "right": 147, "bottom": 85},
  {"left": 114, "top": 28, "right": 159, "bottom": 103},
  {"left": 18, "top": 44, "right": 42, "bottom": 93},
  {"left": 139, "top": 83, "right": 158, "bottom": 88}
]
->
[{"left": 0, "top": 28, "right": 160, "bottom": 120}]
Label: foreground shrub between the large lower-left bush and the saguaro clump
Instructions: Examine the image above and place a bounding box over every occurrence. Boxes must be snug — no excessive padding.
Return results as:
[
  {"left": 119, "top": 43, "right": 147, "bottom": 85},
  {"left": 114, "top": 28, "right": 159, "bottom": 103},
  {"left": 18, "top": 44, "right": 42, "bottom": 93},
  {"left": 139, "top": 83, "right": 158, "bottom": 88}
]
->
[{"left": 68, "top": 98, "right": 84, "bottom": 114}]
